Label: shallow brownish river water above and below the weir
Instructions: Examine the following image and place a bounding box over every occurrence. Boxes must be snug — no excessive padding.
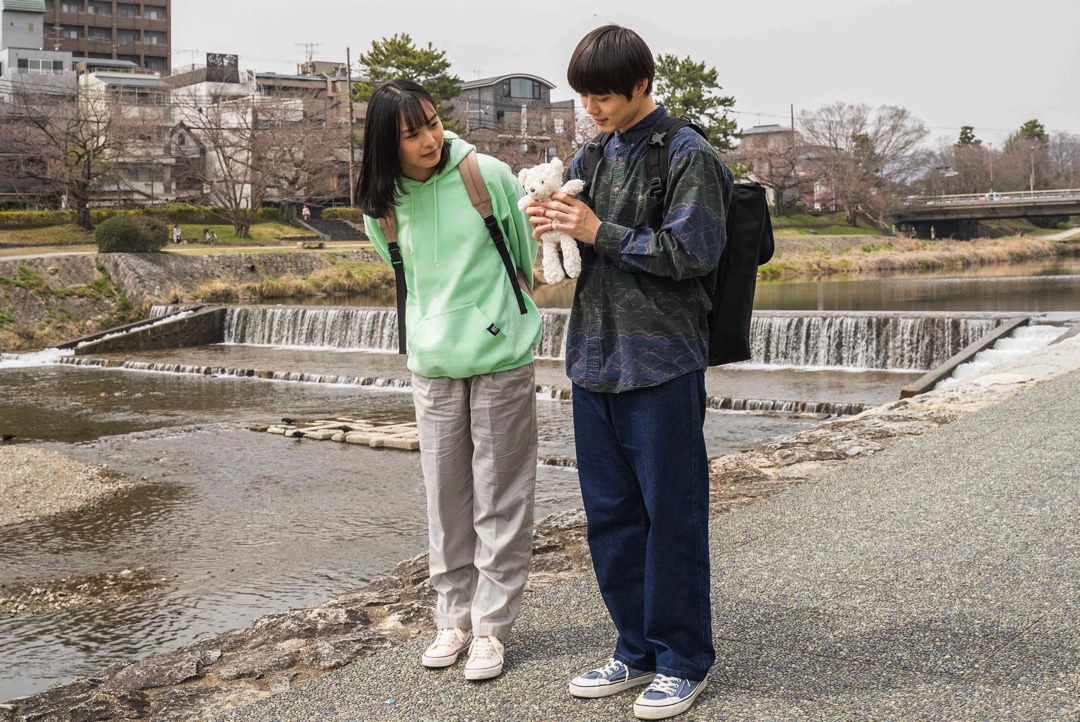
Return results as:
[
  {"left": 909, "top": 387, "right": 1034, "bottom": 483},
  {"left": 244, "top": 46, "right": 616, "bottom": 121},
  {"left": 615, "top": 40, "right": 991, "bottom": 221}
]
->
[{"left": 0, "top": 257, "right": 1080, "bottom": 700}]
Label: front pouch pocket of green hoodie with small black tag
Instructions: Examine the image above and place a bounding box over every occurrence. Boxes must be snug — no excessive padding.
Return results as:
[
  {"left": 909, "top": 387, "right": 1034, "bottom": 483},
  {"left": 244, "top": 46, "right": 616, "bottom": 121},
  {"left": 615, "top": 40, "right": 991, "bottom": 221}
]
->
[{"left": 408, "top": 303, "right": 514, "bottom": 379}]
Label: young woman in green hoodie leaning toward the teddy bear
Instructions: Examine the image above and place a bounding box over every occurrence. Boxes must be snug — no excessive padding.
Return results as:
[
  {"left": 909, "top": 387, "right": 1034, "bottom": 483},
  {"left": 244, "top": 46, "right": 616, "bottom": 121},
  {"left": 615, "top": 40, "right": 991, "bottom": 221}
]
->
[{"left": 357, "top": 80, "right": 541, "bottom": 680}]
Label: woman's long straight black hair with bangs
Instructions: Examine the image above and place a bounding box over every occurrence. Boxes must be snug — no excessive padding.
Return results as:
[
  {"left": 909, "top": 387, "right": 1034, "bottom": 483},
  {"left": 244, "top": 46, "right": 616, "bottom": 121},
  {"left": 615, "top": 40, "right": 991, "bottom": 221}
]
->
[{"left": 356, "top": 80, "right": 450, "bottom": 218}]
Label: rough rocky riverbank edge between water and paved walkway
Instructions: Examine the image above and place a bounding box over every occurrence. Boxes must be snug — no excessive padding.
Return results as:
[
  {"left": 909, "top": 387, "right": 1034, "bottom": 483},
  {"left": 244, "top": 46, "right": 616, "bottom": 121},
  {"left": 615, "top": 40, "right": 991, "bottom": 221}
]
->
[{"left": 6, "top": 330, "right": 1080, "bottom": 722}]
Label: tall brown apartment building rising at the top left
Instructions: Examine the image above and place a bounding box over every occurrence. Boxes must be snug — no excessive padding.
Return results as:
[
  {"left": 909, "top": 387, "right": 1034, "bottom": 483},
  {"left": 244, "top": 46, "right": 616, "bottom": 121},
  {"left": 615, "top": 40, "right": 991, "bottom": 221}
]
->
[{"left": 44, "top": 0, "right": 173, "bottom": 76}]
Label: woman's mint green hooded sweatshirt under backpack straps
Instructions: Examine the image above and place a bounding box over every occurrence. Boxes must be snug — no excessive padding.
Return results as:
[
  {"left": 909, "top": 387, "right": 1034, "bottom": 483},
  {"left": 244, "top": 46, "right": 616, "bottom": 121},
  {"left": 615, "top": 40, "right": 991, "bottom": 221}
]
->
[{"left": 364, "top": 132, "right": 541, "bottom": 379}]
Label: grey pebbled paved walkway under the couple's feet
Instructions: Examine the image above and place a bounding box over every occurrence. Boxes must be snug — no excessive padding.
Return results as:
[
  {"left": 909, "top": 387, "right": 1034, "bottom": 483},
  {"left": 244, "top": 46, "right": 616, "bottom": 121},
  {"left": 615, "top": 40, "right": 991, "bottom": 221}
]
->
[{"left": 221, "top": 337, "right": 1080, "bottom": 722}]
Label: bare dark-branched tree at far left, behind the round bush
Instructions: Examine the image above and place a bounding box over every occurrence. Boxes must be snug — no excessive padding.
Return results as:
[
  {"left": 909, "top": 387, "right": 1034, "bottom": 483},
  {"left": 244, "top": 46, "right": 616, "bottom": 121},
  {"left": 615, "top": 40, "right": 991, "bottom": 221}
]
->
[{"left": 0, "top": 79, "right": 144, "bottom": 225}]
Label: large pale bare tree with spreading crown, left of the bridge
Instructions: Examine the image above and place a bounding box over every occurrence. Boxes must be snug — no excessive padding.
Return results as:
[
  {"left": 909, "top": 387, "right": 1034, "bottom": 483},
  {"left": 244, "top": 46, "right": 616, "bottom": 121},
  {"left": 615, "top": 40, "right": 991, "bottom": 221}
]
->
[{"left": 800, "top": 103, "right": 928, "bottom": 226}]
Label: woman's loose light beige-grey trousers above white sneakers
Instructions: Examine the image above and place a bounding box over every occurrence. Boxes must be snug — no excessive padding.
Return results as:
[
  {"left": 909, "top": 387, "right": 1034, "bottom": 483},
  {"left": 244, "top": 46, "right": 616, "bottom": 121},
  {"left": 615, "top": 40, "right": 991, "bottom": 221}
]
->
[{"left": 413, "top": 364, "right": 537, "bottom": 639}]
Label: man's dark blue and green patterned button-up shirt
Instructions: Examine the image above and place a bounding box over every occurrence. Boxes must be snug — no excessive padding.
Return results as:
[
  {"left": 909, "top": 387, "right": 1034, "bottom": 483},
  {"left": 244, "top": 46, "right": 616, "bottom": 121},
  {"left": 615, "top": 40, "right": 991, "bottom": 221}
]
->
[{"left": 566, "top": 107, "right": 733, "bottom": 392}]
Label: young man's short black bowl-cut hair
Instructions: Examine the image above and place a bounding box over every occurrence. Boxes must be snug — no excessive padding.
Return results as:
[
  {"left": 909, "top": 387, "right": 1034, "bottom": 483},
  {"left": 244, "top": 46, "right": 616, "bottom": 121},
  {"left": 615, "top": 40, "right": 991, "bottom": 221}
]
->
[{"left": 566, "top": 25, "right": 657, "bottom": 100}]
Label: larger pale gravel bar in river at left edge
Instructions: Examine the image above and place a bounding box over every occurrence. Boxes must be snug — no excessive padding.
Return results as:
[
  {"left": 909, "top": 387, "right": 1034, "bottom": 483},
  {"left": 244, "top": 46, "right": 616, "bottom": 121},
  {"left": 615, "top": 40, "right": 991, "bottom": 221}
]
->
[{"left": 0, "top": 446, "right": 130, "bottom": 527}]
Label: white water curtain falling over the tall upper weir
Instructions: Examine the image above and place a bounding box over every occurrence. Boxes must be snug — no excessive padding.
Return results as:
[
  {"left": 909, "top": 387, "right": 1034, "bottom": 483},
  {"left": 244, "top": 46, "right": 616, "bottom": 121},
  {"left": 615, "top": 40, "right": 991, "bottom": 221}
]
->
[{"left": 162, "top": 305, "right": 1015, "bottom": 371}]
